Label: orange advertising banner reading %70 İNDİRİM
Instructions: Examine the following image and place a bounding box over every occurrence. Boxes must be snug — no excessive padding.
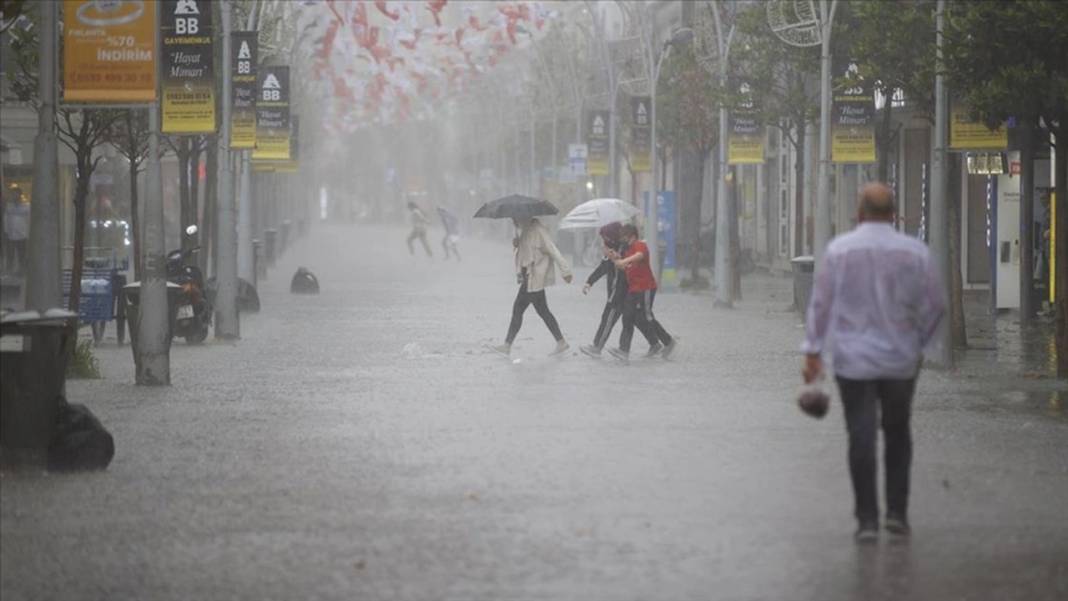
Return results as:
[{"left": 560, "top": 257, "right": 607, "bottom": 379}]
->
[{"left": 63, "top": 0, "right": 156, "bottom": 102}]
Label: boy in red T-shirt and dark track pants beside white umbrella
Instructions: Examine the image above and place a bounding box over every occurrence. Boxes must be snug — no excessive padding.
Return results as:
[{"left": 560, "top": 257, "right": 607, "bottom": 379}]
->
[{"left": 609, "top": 224, "right": 676, "bottom": 361}]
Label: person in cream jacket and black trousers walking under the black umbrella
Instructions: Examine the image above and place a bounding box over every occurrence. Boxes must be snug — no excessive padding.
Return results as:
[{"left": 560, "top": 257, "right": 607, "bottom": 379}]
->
[{"left": 493, "top": 219, "right": 571, "bottom": 354}]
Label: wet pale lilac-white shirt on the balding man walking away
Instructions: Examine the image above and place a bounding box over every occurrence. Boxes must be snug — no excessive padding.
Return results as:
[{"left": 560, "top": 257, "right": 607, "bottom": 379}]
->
[{"left": 801, "top": 222, "right": 945, "bottom": 380}]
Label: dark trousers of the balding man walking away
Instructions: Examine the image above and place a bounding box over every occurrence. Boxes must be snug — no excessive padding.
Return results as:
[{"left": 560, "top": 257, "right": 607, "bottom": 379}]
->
[{"left": 837, "top": 377, "right": 916, "bottom": 523}]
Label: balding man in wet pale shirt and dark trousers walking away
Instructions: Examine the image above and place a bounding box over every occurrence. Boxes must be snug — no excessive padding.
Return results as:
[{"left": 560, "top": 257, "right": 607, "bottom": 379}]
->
[{"left": 801, "top": 184, "right": 945, "bottom": 542}]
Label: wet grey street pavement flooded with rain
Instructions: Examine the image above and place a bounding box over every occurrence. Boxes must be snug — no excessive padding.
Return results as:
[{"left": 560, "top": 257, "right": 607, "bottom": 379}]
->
[{"left": 0, "top": 226, "right": 1068, "bottom": 601}]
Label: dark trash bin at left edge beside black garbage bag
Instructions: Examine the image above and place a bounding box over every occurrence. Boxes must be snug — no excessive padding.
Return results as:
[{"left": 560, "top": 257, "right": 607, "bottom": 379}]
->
[{"left": 0, "top": 309, "right": 78, "bottom": 468}]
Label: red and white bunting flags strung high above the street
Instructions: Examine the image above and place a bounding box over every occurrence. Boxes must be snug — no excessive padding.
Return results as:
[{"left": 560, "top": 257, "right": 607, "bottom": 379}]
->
[{"left": 301, "top": 0, "right": 552, "bottom": 131}]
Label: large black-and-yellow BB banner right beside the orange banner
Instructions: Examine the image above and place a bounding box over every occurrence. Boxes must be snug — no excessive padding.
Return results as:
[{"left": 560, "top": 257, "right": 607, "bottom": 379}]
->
[{"left": 159, "top": 0, "right": 215, "bottom": 133}]
